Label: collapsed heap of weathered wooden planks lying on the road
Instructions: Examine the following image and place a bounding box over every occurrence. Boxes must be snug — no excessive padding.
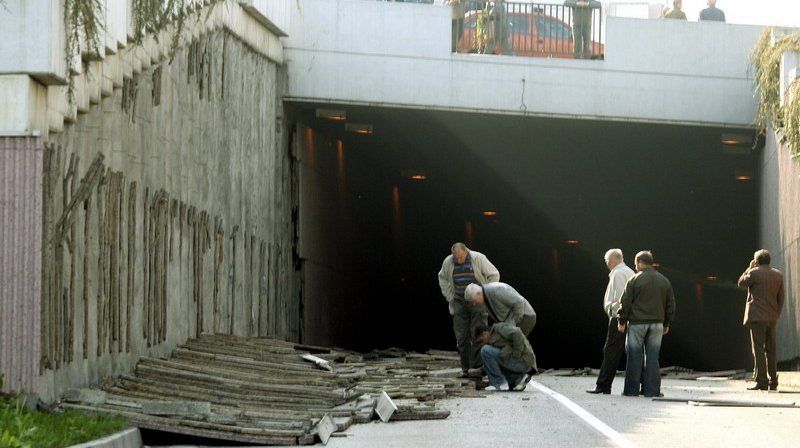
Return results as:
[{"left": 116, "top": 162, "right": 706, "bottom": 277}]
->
[{"left": 64, "top": 335, "right": 482, "bottom": 445}]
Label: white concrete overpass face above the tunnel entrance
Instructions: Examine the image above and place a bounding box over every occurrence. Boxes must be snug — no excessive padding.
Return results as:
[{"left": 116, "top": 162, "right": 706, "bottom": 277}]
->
[{"left": 283, "top": 0, "right": 761, "bottom": 128}]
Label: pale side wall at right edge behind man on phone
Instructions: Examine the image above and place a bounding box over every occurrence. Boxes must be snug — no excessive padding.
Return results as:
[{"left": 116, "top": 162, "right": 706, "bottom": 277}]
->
[{"left": 760, "top": 130, "right": 800, "bottom": 366}]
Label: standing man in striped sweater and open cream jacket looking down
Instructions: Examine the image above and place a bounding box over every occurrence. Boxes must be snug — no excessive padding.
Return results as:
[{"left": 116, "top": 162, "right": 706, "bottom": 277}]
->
[{"left": 439, "top": 243, "right": 500, "bottom": 377}]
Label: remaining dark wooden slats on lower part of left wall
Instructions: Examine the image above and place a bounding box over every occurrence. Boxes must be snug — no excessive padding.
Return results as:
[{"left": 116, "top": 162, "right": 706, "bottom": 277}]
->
[{"left": 40, "top": 146, "right": 283, "bottom": 370}]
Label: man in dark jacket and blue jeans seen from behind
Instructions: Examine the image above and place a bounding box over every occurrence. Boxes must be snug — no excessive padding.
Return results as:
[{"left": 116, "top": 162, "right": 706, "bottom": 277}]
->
[{"left": 617, "top": 250, "right": 675, "bottom": 397}]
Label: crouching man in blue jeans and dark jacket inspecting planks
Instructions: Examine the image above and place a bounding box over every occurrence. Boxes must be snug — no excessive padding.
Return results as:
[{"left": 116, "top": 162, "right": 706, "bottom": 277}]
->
[{"left": 474, "top": 322, "right": 536, "bottom": 391}]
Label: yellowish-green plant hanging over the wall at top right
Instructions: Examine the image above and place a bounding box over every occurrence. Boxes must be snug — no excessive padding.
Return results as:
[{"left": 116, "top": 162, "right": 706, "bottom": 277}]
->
[{"left": 750, "top": 27, "right": 800, "bottom": 158}]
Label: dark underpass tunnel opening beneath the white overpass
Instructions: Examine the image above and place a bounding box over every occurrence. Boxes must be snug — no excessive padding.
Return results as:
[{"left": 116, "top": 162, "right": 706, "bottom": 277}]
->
[{"left": 292, "top": 104, "right": 758, "bottom": 370}]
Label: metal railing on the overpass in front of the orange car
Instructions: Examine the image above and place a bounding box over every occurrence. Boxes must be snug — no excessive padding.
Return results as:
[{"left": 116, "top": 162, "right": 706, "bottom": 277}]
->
[{"left": 453, "top": 0, "right": 604, "bottom": 59}]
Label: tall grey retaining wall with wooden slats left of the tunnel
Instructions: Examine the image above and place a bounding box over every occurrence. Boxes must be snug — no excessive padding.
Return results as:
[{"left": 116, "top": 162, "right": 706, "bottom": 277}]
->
[{"left": 0, "top": 31, "right": 300, "bottom": 400}]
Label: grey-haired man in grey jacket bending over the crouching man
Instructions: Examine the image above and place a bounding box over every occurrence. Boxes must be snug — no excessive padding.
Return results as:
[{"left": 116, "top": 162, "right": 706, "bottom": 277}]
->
[{"left": 464, "top": 282, "right": 536, "bottom": 337}]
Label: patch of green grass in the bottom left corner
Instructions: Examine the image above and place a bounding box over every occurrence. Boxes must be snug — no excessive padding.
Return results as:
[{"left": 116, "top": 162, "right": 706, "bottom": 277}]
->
[{"left": 0, "top": 398, "right": 128, "bottom": 448}]
